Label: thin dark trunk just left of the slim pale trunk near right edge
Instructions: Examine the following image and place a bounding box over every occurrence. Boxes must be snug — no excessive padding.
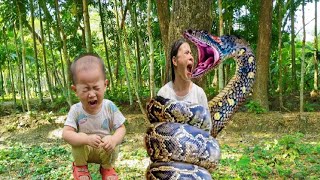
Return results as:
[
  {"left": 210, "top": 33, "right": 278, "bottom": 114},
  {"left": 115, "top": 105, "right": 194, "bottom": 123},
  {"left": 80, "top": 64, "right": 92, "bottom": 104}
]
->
[{"left": 290, "top": 0, "right": 297, "bottom": 92}]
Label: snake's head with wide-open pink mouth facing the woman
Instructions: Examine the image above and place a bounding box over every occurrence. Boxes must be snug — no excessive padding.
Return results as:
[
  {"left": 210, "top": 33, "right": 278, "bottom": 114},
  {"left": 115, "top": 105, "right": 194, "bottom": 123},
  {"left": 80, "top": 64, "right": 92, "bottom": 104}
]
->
[{"left": 183, "top": 30, "right": 221, "bottom": 78}]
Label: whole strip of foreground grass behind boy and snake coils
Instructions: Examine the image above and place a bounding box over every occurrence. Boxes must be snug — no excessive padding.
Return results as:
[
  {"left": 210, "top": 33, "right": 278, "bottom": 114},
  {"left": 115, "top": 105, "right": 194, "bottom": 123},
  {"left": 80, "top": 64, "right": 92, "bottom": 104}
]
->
[{"left": 0, "top": 133, "right": 320, "bottom": 179}]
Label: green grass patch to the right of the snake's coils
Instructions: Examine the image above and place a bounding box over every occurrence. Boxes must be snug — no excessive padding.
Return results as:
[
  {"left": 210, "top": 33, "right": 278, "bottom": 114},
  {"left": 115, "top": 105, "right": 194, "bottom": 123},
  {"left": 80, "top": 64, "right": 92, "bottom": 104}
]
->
[{"left": 212, "top": 133, "right": 320, "bottom": 179}]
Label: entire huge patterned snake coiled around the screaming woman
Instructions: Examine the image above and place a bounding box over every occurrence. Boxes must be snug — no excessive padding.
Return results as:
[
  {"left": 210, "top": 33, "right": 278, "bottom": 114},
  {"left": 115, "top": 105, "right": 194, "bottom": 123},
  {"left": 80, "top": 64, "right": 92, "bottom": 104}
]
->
[{"left": 145, "top": 30, "right": 256, "bottom": 180}]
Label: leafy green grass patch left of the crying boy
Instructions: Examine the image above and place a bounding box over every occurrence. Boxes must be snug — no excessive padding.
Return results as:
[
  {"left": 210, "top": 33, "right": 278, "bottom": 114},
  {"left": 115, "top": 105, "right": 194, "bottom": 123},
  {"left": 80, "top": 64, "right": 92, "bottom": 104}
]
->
[{"left": 0, "top": 142, "right": 70, "bottom": 179}]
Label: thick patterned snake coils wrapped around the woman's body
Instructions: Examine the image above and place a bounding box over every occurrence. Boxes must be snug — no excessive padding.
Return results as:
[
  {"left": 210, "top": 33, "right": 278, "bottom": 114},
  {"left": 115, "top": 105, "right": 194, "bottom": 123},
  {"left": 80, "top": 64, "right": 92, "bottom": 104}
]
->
[{"left": 145, "top": 96, "right": 220, "bottom": 179}]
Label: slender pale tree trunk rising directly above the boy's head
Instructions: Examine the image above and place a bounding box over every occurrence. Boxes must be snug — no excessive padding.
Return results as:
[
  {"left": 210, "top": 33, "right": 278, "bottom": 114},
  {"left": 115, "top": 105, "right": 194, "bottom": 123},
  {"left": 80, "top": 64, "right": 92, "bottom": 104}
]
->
[{"left": 82, "top": 0, "right": 93, "bottom": 52}]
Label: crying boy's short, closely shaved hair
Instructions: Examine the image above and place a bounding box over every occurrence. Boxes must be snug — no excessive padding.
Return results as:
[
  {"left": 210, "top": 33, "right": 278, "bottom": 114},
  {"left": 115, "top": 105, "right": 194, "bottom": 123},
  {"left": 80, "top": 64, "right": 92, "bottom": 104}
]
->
[{"left": 70, "top": 53, "right": 106, "bottom": 84}]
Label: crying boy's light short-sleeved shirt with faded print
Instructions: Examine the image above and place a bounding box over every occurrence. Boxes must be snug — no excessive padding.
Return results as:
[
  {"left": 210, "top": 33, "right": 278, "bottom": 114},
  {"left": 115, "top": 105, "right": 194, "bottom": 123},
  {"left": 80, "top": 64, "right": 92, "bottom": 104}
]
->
[{"left": 64, "top": 99, "right": 125, "bottom": 137}]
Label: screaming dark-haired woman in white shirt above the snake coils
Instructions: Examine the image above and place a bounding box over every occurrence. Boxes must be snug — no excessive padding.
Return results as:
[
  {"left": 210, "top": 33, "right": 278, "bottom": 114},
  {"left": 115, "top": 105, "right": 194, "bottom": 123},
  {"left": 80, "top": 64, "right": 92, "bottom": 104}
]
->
[{"left": 157, "top": 39, "right": 208, "bottom": 109}]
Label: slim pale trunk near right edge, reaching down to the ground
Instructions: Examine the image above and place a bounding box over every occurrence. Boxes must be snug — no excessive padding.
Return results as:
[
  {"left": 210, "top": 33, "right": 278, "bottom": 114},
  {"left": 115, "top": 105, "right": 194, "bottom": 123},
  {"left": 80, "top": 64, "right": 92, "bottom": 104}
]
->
[{"left": 300, "top": 0, "right": 306, "bottom": 114}]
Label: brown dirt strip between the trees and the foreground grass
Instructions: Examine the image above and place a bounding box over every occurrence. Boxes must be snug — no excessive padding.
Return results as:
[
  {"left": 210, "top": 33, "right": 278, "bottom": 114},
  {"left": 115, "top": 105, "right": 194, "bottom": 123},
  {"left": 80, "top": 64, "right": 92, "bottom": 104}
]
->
[{"left": 0, "top": 112, "right": 320, "bottom": 150}]
